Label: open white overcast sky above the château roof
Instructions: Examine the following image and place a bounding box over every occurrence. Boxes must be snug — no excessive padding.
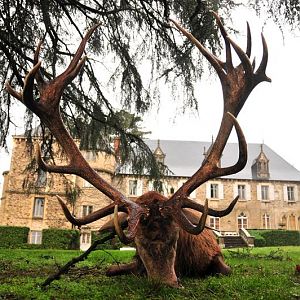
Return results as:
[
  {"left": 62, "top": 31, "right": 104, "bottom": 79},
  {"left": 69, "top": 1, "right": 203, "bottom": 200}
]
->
[{"left": 0, "top": 9, "right": 300, "bottom": 195}]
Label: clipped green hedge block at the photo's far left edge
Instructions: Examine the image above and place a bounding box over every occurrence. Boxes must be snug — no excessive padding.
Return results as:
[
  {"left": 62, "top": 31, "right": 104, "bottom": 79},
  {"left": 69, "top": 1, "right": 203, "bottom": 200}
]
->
[{"left": 0, "top": 226, "right": 29, "bottom": 248}]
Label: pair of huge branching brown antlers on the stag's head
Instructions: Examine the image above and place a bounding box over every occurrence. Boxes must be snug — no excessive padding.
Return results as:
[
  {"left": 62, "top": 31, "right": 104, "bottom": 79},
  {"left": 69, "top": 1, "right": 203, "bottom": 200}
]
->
[{"left": 6, "top": 12, "right": 271, "bottom": 242}]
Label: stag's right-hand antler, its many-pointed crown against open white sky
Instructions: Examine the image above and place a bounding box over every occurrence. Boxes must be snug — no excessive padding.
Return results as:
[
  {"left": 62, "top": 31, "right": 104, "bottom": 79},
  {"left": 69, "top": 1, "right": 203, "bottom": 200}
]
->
[{"left": 164, "top": 12, "right": 271, "bottom": 233}]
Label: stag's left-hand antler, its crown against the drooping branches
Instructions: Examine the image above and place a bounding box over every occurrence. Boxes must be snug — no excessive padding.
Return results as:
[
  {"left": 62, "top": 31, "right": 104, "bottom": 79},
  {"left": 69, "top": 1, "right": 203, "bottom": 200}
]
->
[{"left": 6, "top": 24, "right": 145, "bottom": 238}]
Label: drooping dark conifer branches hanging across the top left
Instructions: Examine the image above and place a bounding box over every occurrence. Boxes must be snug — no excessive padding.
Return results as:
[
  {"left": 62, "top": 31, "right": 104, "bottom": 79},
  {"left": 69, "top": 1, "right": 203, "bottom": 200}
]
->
[{"left": 0, "top": 0, "right": 299, "bottom": 175}]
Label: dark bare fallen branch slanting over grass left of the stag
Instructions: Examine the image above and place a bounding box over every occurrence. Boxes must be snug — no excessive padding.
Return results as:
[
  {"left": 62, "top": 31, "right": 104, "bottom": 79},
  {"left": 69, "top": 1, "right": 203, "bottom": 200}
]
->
[{"left": 41, "top": 233, "right": 115, "bottom": 288}]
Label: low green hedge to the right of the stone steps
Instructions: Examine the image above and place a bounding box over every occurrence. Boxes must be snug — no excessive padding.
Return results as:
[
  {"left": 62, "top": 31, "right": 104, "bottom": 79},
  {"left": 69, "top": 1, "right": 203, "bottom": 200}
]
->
[{"left": 248, "top": 229, "right": 300, "bottom": 247}]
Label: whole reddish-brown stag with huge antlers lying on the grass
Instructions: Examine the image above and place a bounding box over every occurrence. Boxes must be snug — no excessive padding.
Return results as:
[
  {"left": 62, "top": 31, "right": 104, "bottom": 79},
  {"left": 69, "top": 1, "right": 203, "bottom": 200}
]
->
[{"left": 6, "top": 12, "right": 270, "bottom": 287}]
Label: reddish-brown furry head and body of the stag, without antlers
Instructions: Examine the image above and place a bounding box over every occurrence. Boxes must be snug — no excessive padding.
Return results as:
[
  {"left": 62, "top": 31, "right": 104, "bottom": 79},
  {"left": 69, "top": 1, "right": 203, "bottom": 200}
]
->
[{"left": 103, "top": 192, "right": 230, "bottom": 287}]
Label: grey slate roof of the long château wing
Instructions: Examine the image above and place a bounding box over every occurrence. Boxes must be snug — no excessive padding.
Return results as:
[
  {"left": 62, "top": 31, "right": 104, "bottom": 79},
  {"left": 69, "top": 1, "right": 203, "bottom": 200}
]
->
[{"left": 145, "top": 139, "right": 300, "bottom": 181}]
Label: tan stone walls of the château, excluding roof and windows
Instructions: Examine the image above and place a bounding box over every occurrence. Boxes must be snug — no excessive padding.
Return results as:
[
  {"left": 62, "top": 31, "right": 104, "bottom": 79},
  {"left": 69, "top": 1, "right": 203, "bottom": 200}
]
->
[{"left": 0, "top": 137, "right": 300, "bottom": 231}]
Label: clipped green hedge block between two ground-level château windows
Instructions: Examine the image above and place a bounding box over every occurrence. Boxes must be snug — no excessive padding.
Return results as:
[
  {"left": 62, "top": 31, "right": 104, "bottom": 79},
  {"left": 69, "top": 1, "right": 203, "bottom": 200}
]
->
[{"left": 42, "top": 228, "right": 80, "bottom": 250}]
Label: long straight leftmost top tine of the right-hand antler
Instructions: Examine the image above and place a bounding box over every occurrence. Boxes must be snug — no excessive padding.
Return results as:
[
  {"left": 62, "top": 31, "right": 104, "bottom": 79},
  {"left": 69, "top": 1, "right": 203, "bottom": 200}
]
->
[{"left": 169, "top": 19, "right": 225, "bottom": 78}]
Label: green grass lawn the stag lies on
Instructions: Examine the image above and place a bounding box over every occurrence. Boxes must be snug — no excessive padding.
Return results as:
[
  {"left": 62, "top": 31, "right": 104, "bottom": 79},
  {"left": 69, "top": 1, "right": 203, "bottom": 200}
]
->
[{"left": 0, "top": 247, "right": 300, "bottom": 300}]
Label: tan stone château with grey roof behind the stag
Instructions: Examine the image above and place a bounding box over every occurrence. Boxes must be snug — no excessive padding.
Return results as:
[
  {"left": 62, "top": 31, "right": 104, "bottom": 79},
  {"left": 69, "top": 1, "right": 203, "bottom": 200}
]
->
[{"left": 0, "top": 136, "right": 300, "bottom": 249}]
